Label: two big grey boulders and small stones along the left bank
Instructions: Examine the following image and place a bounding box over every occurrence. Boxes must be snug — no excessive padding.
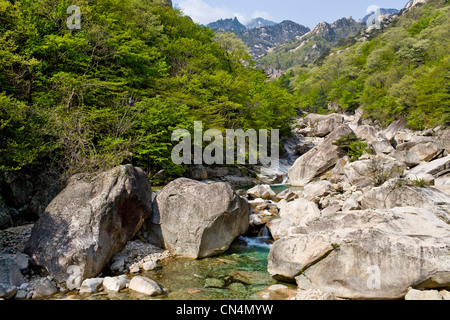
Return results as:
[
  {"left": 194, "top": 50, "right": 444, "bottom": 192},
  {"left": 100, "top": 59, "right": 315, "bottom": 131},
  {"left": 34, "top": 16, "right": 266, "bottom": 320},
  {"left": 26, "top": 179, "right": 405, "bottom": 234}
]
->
[{"left": 0, "top": 165, "right": 250, "bottom": 299}]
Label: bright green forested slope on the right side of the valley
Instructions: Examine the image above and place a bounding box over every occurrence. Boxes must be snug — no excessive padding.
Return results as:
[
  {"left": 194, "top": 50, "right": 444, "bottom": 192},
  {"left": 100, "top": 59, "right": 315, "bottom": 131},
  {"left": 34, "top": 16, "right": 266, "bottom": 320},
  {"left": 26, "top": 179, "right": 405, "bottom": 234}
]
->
[{"left": 280, "top": 0, "right": 450, "bottom": 130}]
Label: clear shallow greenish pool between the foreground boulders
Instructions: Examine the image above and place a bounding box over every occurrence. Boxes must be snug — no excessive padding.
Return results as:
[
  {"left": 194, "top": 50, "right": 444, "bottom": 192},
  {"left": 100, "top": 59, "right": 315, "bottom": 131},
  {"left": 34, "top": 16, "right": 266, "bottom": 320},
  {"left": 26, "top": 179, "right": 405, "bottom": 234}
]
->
[{"left": 143, "top": 238, "right": 277, "bottom": 300}]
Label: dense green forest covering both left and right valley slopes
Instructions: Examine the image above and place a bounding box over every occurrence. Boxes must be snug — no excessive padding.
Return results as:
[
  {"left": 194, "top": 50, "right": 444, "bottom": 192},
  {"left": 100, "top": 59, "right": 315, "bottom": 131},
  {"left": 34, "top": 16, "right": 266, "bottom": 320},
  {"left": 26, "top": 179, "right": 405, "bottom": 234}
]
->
[{"left": 0, "top": 0, "right": 450, "bottom": 185}]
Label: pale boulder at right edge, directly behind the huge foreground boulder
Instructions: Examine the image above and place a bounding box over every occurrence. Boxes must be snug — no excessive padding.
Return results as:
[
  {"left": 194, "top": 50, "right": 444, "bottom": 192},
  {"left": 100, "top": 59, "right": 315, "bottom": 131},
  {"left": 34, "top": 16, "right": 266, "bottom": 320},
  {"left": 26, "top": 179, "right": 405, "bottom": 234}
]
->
[{"left": 361, "top": 179, "right": 450, "bottom": 223}]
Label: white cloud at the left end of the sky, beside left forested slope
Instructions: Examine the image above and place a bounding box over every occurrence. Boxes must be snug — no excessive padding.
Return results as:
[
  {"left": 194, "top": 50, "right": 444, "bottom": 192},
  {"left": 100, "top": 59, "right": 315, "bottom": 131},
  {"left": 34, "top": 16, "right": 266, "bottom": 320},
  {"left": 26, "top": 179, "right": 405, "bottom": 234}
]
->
[{"left": 178, "top": 0, "right": 250, "bottom": 24}]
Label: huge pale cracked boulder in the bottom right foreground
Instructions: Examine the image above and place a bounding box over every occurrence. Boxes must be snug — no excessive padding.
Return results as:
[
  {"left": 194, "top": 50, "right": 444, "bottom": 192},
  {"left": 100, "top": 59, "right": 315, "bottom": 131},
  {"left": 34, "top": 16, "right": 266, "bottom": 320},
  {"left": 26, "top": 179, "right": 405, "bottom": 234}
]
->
[{"left": 268, "top": 207, "right": 450, "bottom": 299}]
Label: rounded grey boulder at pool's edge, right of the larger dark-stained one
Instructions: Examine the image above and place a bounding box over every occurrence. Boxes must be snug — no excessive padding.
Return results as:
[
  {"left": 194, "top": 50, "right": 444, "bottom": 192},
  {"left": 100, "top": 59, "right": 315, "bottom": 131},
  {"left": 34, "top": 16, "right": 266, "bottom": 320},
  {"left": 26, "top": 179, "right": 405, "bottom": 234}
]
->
[{"left": 146, "top": 178, "right": 250, "bottom": 259}]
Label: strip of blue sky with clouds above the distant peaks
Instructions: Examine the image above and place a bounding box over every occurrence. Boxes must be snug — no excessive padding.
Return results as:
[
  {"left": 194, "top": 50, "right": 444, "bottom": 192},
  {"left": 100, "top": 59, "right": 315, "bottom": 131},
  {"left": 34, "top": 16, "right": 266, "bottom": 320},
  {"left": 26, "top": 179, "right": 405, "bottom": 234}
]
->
[{"left": 172, "top": 0, "right": 408, "bottom": 28}]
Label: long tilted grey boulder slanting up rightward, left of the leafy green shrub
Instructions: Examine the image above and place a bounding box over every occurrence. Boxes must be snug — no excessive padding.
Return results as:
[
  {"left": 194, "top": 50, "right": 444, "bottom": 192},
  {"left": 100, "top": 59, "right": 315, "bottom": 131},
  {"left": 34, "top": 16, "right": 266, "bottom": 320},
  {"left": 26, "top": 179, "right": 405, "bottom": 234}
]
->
[{"left": 288, "top": 125, "right": 353, "bottom": 186}]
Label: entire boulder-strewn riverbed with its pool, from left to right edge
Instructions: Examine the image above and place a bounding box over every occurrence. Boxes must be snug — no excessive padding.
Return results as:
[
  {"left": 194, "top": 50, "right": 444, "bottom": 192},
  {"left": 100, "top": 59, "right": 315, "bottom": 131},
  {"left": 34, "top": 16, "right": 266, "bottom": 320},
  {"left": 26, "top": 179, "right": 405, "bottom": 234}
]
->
[{"left": 0, "top": 111, "right": 450, "bottom": 300}]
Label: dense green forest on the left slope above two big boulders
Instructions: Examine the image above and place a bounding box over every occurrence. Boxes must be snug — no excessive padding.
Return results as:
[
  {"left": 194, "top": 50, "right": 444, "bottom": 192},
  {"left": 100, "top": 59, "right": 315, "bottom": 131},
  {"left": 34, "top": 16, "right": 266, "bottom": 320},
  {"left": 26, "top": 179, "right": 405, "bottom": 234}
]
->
[{"left": 0, "top": 0, "right": 295, "bottom": 181}]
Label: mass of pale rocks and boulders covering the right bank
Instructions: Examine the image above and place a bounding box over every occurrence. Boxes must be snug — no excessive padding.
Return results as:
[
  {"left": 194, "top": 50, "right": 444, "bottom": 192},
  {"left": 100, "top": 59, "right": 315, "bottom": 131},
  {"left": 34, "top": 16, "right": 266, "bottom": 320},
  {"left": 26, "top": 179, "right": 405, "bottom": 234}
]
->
[{"left": 267, "top": 113, "right": 450, "bottom": 299}]
